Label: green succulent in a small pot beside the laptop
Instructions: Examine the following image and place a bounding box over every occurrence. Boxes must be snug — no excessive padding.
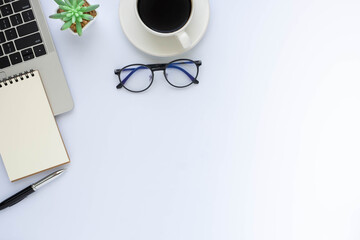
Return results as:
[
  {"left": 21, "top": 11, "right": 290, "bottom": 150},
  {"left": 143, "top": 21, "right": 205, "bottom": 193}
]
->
[{"left": 50, "top": 0, "right": 99, "bottom": 36}]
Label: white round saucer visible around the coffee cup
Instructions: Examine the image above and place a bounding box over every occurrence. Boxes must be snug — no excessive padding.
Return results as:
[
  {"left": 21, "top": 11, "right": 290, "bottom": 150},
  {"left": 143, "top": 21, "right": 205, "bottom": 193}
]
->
[{"left": 119, "top": 0, "right": 210, "bottom": 57}]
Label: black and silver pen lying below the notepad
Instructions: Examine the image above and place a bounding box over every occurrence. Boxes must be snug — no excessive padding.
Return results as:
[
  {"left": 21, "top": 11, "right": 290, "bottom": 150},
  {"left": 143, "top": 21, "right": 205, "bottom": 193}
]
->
[{"left": 0, "top": 169, "right": 65, "bottom": 210}]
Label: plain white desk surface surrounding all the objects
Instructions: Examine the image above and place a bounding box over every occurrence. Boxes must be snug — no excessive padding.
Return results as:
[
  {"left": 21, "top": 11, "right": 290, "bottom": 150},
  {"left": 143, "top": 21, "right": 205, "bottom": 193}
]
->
[{"left": 0, "top": 0, "right": 360, "bottom": 240}]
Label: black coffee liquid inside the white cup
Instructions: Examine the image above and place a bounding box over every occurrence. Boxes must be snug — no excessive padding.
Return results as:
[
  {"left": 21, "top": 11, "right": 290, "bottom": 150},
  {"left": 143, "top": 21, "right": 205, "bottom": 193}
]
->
[{"left": 137, "top": 0, "right": 191, "bottom": 33}]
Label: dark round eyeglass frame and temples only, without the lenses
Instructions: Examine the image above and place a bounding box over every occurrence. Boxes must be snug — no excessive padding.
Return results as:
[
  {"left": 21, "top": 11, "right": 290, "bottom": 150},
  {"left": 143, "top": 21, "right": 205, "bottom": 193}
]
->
[{"left": 115, "top": 58, "right": 202, "bottom": 93}]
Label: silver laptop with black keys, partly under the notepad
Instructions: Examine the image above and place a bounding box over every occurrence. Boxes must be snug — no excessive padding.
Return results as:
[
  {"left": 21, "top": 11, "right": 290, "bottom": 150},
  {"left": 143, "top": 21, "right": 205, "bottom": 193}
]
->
[{"left": 0, "top": 0, "right": 74, "bottom": 115}]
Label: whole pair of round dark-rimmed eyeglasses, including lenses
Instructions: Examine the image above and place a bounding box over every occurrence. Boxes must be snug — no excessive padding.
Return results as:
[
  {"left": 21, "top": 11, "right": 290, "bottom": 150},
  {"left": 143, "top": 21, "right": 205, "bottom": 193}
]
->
[{"left": 115, "top": 59, "right": 201, "bottom": 93}]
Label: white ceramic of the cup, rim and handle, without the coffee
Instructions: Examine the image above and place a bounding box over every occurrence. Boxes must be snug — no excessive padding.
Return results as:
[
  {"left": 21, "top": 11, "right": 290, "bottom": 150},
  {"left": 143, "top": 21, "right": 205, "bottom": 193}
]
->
[{"left": 135, "top": 0, "right": 196, "bottom": 49}]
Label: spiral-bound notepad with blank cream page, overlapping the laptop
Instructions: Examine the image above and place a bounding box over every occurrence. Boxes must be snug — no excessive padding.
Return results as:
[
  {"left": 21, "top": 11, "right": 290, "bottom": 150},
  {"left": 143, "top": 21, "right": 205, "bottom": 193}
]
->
[{"left": 0, "top": 71, "right": 70, "bottom": 181}]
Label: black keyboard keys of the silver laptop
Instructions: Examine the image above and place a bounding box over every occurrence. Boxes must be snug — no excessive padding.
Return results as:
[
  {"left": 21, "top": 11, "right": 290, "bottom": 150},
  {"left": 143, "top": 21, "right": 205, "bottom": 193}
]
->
[{"left": 0, "top": 0, "right": 46, "bottom": 69}]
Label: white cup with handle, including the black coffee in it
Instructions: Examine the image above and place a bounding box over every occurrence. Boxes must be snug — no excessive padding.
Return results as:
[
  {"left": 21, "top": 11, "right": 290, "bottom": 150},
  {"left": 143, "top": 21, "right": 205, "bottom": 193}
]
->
[{"left": 135, "top": 0, "right": 196, "bottom": 49}]
